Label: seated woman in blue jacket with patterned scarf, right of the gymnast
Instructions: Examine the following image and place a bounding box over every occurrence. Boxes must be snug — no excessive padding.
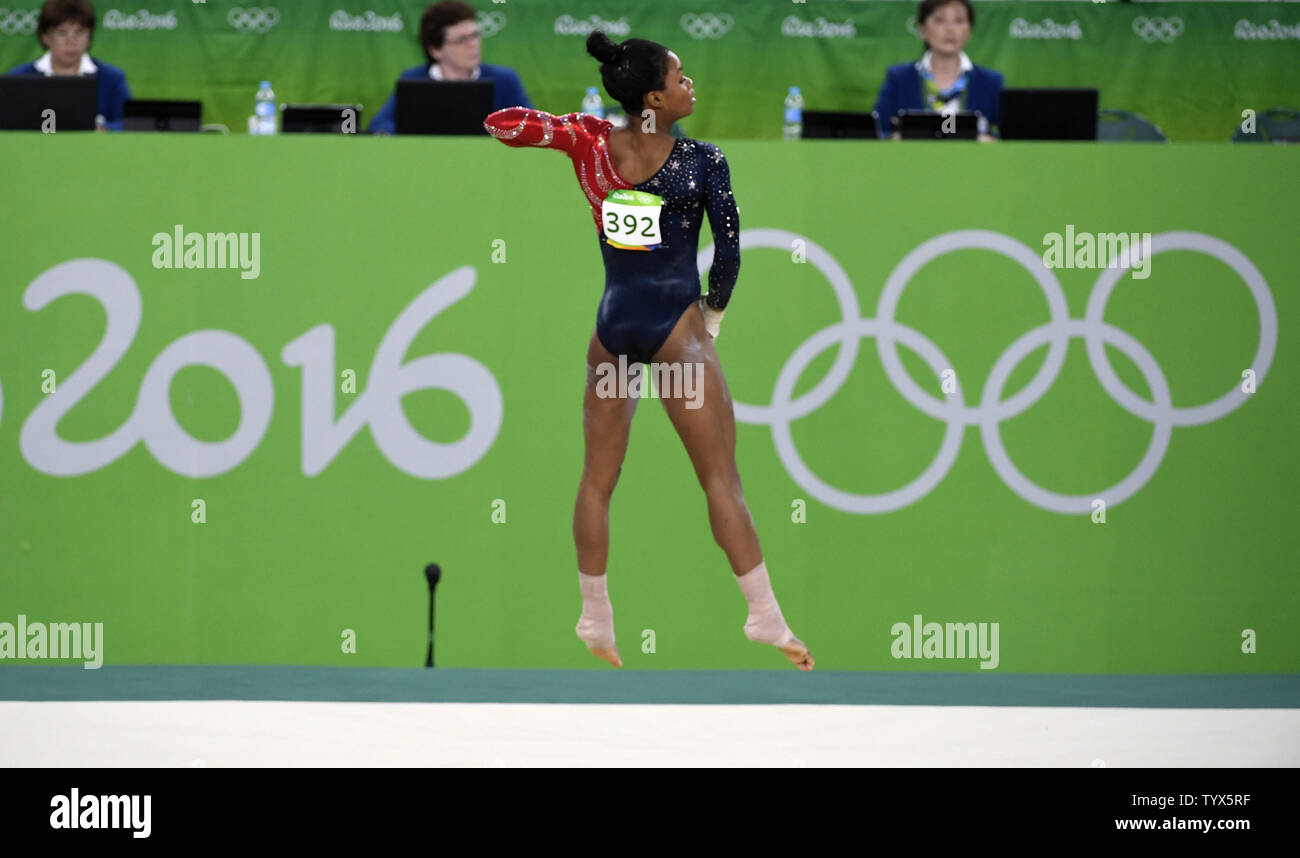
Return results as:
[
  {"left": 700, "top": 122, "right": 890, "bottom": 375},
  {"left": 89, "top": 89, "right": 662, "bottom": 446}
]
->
[{"left": 875, "top": 0, "right": 1002, "bottom": 139}]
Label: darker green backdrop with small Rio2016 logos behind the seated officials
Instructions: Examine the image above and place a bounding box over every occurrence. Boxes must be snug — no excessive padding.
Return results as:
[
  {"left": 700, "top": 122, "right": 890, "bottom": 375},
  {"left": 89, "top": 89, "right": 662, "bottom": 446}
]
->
[{"left": 0, "top": 0, "right": 1300, "bottom": 142}]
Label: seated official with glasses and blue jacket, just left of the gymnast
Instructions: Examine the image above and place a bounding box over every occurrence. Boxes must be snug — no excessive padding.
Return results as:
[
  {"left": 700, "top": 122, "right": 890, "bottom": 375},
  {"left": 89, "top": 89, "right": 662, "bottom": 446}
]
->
[{"left": 367, "top": 0, "right": 533, "bottom": 134}]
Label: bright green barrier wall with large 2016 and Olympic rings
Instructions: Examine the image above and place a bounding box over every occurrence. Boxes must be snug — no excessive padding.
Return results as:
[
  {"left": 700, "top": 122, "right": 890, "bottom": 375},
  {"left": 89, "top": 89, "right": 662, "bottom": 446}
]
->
[{"left": 0, "top": 134, "right": 1300, "bottom": 673}]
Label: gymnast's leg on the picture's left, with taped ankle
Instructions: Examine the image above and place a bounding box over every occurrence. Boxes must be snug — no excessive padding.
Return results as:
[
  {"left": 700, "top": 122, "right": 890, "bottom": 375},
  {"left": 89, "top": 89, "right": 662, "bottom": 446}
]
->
[{"left": 573, "top": 325, "right": 637, "bottom": 667}]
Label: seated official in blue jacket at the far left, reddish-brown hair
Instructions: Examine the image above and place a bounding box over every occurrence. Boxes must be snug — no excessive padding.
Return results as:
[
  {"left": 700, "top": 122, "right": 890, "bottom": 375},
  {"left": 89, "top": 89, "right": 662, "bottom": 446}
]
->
[{"left": 9, "top": 0, "right": 131, "bottom": 131}]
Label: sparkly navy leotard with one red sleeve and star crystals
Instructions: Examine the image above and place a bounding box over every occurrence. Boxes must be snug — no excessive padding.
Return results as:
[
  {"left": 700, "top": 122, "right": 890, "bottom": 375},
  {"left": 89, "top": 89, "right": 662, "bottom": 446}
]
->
[{"left": 484, "top": 108, "right": 740, "bottom": 363}]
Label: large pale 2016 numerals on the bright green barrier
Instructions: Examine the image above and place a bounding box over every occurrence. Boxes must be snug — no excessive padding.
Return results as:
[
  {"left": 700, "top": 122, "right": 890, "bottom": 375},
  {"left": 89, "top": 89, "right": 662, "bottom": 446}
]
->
[{"left": 0, "top": 259, "right": 503, "bottom": 480}]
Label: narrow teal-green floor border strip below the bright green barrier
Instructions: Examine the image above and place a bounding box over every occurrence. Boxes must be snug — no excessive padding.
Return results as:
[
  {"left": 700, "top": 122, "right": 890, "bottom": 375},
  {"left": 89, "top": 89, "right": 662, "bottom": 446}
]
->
[{"left": 0, "top": 666, "right": 1300, "bottom": 709}]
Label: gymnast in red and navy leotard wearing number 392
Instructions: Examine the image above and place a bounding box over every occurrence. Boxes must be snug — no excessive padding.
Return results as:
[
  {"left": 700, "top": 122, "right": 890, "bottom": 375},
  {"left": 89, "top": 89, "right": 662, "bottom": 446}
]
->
[{"left": 484, "top": 30, "right": 813, "bottom": 671}]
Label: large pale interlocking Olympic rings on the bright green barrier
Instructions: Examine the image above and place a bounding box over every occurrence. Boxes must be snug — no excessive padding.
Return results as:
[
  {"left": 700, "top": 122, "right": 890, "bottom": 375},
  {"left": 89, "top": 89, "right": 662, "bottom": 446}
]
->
[{"left": 697, "top": 229, "right": 1278, "bottom": 515}]
